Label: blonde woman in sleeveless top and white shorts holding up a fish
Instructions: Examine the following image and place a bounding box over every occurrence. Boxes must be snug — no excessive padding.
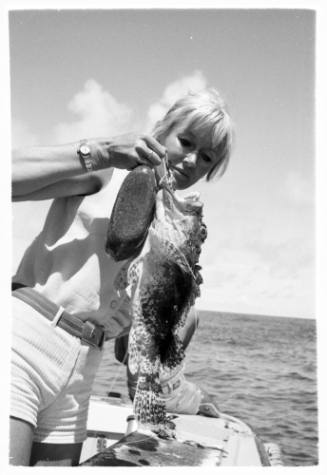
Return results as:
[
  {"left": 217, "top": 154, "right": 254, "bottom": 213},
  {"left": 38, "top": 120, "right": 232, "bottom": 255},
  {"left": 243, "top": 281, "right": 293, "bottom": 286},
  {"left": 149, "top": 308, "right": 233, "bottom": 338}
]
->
[{"left": 10, "top": 90, "right": 232, "bottom": 465}]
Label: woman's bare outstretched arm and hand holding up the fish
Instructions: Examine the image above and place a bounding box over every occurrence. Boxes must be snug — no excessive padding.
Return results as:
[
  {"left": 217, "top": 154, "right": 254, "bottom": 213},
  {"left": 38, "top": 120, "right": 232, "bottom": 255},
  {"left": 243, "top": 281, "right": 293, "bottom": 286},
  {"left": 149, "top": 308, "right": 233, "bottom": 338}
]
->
[{"left": 12, "top": 134, "right": 165, "bottom": 201}]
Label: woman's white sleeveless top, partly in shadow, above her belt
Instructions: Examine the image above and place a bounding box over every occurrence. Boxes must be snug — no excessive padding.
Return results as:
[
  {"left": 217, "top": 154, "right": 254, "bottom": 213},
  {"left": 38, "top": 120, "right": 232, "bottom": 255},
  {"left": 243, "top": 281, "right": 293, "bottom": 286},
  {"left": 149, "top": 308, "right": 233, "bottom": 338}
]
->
[{"left": 13, "top": 169, "right": 131, "bottom": 338}]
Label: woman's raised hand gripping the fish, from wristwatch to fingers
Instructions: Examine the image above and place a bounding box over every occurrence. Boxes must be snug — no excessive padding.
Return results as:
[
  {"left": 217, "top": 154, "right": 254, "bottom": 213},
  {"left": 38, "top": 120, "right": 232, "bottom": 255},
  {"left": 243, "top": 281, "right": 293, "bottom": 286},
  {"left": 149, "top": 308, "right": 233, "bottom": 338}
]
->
[{"left": 88, "top": 134, "right": 166, "bottom": 170}]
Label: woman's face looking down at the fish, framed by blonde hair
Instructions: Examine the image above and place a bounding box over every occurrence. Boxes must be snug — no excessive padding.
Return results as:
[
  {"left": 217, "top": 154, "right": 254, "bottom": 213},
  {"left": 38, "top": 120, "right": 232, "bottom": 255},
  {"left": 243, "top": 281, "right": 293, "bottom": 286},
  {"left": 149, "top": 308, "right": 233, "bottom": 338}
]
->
[{"left": 162, "top": 123, "right": 219, "bottom": 190}]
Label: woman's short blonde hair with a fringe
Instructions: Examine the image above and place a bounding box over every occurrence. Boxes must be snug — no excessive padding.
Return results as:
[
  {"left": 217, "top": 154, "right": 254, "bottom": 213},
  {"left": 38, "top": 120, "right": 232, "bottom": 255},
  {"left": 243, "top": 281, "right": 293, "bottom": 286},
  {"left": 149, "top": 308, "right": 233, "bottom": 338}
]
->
[{"left": 152, "top": 88, "right": 233, "bottom": 181}]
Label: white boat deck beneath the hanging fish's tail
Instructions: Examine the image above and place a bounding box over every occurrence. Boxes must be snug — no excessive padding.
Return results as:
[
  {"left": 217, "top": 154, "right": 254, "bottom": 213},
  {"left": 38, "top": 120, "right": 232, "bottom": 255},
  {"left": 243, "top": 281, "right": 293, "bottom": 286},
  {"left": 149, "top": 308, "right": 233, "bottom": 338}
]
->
[{"left": 80, "top": 396, "right": 271, "bottom": 467}]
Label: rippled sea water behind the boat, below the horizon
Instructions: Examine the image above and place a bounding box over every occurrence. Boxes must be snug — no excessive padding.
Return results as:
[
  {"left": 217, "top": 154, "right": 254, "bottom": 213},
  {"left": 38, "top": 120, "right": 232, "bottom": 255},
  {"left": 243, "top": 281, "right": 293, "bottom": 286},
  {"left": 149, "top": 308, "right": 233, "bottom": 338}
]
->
[{"left": 93, "top": 312, "right": 318, "bottom": 466}]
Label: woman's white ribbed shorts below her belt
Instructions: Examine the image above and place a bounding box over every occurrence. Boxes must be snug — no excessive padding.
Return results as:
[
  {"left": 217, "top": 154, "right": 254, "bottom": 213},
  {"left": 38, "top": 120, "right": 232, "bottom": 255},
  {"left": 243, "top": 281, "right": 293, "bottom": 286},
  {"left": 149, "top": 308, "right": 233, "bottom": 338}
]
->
[{"left": 10, "top": 297, "right": 102, "bottom": 444}]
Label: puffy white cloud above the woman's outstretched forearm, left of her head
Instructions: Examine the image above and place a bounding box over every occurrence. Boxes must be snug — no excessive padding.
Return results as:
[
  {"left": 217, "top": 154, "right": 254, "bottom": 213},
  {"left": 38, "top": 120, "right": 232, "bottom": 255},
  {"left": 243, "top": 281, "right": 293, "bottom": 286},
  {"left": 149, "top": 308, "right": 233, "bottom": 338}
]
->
[{"left": 54, "top": 79, "right": 135, "bottom": 143}]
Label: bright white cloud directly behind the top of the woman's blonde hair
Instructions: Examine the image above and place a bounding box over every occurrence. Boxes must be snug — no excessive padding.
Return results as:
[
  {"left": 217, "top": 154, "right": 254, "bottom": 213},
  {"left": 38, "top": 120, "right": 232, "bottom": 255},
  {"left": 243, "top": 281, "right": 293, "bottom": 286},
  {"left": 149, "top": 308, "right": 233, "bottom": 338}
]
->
[{"left": 145, "top": 71, "right": 207, "bottom": 131}]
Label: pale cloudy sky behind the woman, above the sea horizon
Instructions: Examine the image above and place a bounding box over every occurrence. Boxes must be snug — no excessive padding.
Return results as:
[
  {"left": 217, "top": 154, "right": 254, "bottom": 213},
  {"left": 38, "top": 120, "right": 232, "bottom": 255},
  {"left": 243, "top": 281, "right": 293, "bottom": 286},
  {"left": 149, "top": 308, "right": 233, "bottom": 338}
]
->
[{"left": 9, "top": 8, "right": 316, "bottom": 318}]
